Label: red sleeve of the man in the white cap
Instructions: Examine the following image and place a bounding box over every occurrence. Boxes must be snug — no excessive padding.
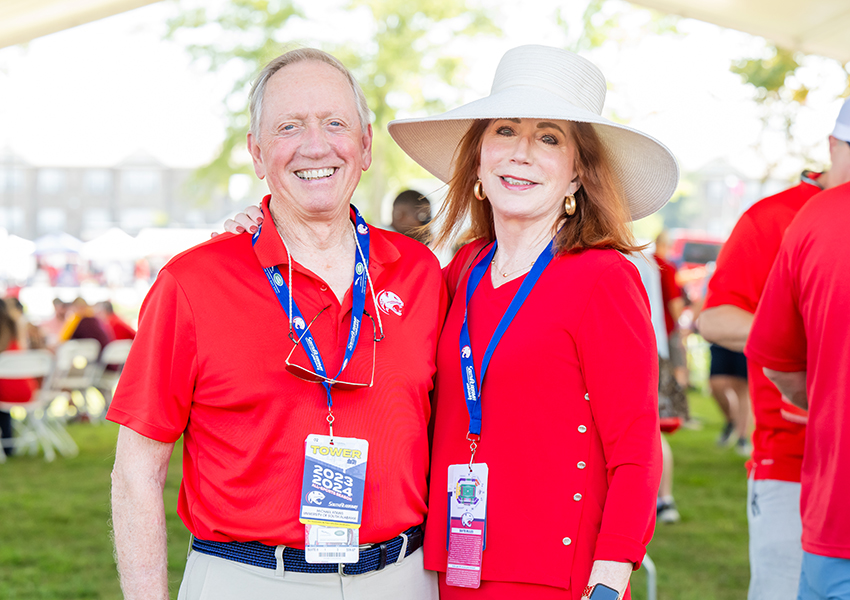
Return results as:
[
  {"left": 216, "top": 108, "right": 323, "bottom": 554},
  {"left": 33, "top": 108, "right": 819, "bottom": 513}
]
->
[{"left": 704, "top": 212, "right": 768, "bottom": 313}]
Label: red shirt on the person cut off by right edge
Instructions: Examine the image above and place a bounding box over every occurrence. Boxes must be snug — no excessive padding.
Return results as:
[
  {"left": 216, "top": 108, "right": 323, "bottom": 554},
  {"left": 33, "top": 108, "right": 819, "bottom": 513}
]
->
[{"left": 746, "top": 183, "right": 850, "bottom": 559}]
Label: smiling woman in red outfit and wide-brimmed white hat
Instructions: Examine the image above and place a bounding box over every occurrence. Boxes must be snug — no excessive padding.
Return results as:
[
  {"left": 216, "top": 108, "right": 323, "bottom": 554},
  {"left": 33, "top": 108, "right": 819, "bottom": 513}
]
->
[{"left": 389, "top": 46, "right": 678, "bottom": 600}]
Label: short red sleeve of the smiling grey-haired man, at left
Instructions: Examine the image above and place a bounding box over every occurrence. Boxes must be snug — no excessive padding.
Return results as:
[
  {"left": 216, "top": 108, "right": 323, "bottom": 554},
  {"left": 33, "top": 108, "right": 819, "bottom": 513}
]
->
[{"left": 107, "top": 270, "right": 198, "bottom": 443}]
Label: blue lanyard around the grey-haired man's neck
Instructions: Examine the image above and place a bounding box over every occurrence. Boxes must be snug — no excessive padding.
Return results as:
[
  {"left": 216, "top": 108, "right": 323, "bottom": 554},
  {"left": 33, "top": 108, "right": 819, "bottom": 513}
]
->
[{"left": 251, "top": 204, "right": 369, "bottom": 408}]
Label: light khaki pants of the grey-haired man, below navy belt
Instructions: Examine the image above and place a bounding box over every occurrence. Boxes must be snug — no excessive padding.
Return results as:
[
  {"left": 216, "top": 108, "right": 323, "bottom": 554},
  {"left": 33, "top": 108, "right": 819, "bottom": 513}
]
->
[{"left": 177, "top": 548, "right": 439, "bottom": 600}]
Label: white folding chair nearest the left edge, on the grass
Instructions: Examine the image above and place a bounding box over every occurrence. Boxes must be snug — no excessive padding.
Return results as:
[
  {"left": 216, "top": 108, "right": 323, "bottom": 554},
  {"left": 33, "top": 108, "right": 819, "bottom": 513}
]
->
[{"left": 0, "top": 350, "right": 78, "bottom": 462}]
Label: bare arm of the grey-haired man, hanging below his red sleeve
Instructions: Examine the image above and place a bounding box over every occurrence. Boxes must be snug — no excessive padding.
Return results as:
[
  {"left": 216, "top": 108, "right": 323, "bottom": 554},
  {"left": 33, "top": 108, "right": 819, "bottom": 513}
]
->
[{"left": 112, "top": 426, "right": 174, "bottom": 600}]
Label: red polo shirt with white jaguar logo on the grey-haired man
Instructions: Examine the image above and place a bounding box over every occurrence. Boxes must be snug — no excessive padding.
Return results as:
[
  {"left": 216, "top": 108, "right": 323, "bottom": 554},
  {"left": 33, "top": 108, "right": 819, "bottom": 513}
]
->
[{"left": 108, "top": 198, "right": 447, "bottom": 548}]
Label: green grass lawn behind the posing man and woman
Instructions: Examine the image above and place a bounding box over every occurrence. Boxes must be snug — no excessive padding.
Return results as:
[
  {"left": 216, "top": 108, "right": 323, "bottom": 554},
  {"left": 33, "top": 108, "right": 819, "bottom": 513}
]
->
[{"left": 0, "top": 394, "right": 749, "bottom": 600}]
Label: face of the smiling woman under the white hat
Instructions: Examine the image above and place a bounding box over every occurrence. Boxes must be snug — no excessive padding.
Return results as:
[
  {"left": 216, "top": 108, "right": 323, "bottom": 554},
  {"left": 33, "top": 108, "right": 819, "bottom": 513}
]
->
[{"left": 478, "top": 119, "right": 579, "bottom": 225}]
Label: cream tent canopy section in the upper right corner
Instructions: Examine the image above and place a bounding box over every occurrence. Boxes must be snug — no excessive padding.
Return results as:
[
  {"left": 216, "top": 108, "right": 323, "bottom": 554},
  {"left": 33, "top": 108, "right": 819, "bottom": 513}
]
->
[{"left": 631, "top": 0, "right": 850, "bottom": 63}]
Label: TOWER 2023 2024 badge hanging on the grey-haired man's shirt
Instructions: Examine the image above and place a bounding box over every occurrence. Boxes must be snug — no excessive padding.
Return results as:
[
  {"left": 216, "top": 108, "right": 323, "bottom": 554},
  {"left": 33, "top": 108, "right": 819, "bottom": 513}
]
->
[{"left": 300, "top": 434, "right": 369, "bottom": 563}]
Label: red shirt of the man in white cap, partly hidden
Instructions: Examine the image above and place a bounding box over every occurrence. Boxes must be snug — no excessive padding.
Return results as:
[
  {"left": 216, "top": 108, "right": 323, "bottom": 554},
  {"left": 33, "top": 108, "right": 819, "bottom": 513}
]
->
[{"left": 705, "top": 177, "right": 820, "bottom": 481}]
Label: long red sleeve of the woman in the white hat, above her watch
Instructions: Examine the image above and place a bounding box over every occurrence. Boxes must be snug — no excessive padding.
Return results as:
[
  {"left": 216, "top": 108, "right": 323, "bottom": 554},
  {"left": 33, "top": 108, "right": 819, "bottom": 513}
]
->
[{"left": 577, "top": 260, "right": 661, "bottom": 565}]
